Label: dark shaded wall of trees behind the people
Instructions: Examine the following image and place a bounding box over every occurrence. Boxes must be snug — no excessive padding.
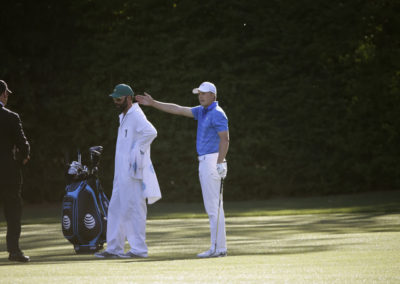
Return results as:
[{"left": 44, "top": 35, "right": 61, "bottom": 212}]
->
[{"left": 0, "top": 0, "right": 400, "bottom": 202}]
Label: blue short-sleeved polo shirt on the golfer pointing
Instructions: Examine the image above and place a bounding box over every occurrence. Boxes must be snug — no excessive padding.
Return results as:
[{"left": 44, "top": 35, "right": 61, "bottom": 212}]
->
[{"left": 191, "top": 102, "right": 228, "bottom": 156}]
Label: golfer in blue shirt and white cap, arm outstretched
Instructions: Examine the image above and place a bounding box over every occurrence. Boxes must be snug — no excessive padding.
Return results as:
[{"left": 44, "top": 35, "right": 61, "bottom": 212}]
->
[{"left": 135, "top": 82, "right": 229, "bottom": 258}]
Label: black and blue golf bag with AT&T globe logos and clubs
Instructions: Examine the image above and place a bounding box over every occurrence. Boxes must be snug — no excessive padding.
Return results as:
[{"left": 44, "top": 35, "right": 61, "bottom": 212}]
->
[{"left": 61, "top": 146, "right": 109, "bottom": 254}]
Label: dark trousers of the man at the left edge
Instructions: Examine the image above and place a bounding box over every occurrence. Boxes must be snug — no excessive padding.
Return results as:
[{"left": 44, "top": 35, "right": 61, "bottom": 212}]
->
[{"left": 0, "top": 181, "right": 22, "bottom": 253}]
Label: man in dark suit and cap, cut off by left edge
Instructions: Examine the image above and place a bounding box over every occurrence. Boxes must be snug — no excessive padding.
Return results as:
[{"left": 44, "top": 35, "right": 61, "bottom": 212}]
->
[{"left": 0, "top": 80, "right": 30, "bottom": 262}]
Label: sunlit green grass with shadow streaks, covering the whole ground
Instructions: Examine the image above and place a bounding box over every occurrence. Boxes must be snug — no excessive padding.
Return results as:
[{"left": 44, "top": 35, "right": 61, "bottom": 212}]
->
[{"left": 0, "top": 192, "right": 400, "bottom": 283}]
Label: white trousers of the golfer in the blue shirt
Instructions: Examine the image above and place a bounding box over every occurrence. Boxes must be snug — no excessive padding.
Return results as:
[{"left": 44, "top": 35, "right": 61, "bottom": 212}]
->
[{"left": 199, "top": 153, "right": 227, "bottom": 250}]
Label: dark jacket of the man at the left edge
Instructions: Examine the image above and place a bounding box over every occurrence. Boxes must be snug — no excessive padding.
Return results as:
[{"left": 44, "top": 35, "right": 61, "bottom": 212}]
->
[{"left": 0, "top": 104, "right": 30, "bottom": 185}]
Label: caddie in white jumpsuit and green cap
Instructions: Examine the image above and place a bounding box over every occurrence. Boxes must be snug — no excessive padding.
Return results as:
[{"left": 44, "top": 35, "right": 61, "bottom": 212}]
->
[{"left": 95, "top": 84, "right": 161, "bottom": 258}]
